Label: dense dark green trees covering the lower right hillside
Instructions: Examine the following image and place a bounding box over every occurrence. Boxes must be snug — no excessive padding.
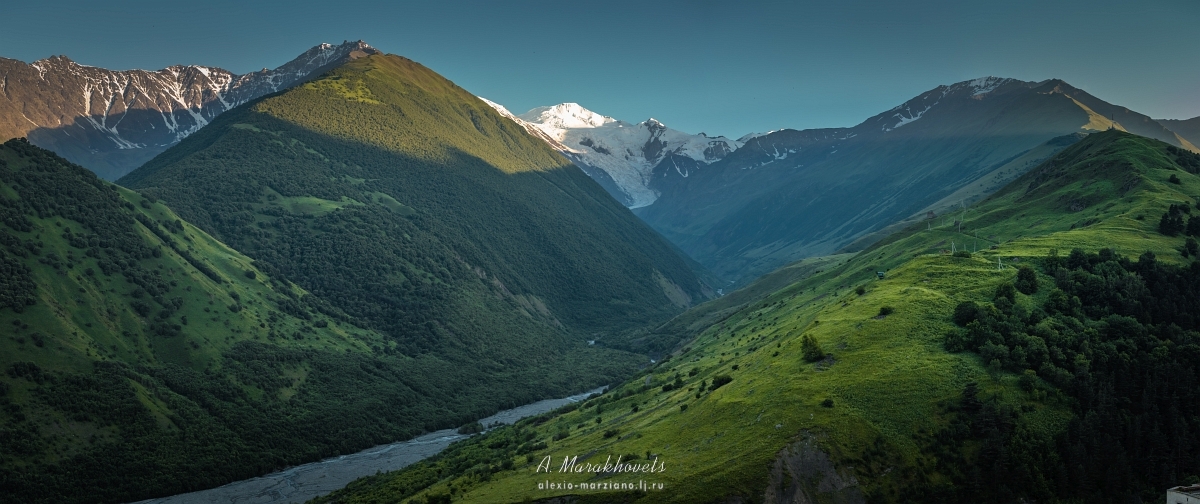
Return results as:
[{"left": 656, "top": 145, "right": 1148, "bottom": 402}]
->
[{"left": 947, "top": 250, "right": 1200, "bottom": 500}]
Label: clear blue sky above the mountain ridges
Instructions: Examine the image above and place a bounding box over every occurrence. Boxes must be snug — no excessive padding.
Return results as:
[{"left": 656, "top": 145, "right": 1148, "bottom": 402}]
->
[{"left": 0, "top": 0, "right": 1200, "bottom": 137}]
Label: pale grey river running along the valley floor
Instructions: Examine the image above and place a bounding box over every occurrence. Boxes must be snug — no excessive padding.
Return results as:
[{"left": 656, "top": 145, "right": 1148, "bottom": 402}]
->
[{"left": 134, "top": 388, "right": 604, "bottom": 504}]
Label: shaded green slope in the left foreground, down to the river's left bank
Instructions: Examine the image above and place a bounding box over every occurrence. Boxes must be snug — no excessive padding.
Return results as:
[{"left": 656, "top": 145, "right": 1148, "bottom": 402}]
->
[{"left": 0, "top": 139, "right": 641, "bottom": 503}]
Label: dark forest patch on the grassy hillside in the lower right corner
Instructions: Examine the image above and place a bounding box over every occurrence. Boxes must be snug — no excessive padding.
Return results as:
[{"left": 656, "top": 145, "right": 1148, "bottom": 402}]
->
[{"left": 936, "top": 250, "right": 1200, "bottom": 503}]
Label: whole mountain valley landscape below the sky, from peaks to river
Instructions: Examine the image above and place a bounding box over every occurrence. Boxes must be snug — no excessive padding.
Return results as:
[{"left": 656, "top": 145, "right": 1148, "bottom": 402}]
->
[{"left": 0, "top": 30, "right": 1200, "bottom": 504}]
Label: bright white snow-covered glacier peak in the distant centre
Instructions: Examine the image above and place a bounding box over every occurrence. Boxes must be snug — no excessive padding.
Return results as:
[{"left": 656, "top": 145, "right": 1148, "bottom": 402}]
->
[{"left": 484, "top": 100, "right": 743, "bottom": 208}]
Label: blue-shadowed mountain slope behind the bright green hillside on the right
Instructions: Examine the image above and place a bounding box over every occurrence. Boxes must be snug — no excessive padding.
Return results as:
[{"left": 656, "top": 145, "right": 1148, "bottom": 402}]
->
[{"left": 636, "top": 78, "right": 1195, "bottom": 282}]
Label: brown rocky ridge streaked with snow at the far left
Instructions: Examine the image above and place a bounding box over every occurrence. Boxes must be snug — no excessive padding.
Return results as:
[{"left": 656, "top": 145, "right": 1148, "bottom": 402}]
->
[{"left": 0, "top": 41, "right": 378, "bottom": 180}]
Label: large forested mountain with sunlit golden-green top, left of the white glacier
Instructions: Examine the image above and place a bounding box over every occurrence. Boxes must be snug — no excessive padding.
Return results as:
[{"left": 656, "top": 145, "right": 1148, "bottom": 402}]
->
[{"left": 121, "top": 56, "right": 707, "bottom": 343}]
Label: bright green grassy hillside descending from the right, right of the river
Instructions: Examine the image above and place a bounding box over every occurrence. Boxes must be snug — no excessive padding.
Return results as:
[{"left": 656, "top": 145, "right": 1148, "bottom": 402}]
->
[{"left": 322, "top": 131, "right": 1200, "bottom": 503}]
